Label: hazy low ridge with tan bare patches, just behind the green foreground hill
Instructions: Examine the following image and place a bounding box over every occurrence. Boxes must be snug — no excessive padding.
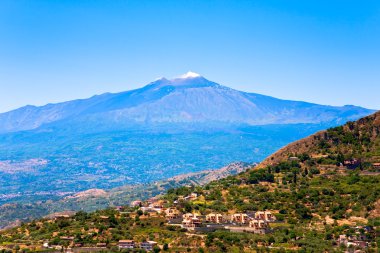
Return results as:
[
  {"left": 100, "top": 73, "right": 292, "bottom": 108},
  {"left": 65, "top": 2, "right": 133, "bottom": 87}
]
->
[{"left": 0, "top": 162, "right": 252, "bottom": 229}]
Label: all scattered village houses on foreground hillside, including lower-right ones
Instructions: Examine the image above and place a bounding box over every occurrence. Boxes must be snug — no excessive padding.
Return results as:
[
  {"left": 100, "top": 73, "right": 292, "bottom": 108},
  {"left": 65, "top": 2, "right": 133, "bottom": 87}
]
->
[{"left": 4, "top": 188, "right": 373, "bottom": 252}]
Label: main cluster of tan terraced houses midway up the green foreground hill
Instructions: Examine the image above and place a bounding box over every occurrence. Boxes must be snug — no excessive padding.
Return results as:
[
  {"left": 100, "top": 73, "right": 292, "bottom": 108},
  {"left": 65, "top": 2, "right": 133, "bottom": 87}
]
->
[{"left": 131, "top": 196, "right": 276, "bottom": 234}]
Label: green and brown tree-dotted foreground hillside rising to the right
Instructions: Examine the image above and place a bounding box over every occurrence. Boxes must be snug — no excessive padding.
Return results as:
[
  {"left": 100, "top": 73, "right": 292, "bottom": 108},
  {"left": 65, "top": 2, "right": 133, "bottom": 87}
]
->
[{"left": 0, "top": 113, "right": 380, "bottom": 252}]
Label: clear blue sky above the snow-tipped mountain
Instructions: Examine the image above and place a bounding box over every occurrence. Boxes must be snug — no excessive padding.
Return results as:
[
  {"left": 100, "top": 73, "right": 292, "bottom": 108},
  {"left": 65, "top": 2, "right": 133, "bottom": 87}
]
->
[{"left": 0, "top": 0, "right": 380, "bottom": 112}]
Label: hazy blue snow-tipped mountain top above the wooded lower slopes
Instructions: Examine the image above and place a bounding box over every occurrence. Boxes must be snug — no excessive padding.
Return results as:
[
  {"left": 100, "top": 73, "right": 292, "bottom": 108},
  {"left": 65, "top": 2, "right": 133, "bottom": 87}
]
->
[{"left": 0, "top": 74, "right": 372, "bottom": 133}]
